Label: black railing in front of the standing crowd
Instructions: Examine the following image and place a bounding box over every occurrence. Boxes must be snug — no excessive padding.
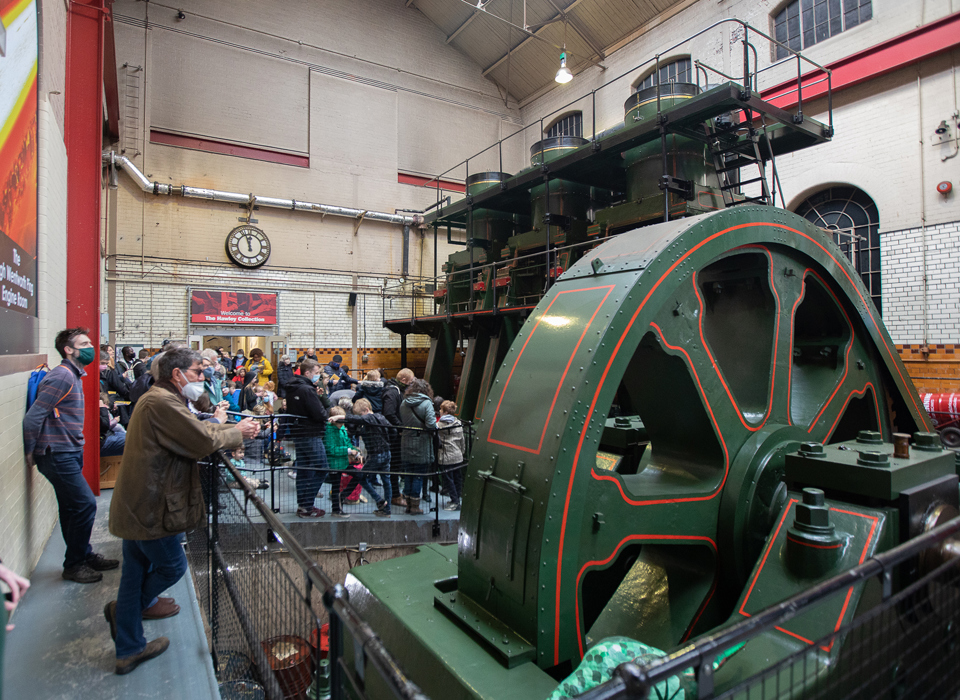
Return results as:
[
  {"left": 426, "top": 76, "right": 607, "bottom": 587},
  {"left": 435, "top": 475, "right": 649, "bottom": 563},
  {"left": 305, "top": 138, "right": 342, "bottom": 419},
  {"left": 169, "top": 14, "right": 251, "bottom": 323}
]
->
[{"left": 218, "top": 413, "right": 474, "bottom": 536}]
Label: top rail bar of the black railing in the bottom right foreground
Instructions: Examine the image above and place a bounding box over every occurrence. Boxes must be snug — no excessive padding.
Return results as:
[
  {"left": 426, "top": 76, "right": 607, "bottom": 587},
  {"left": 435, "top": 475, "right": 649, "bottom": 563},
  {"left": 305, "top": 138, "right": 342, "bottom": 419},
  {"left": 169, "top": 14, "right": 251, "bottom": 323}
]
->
[{"left": 576, "top": 517, "right": 960, "bottom": 700}]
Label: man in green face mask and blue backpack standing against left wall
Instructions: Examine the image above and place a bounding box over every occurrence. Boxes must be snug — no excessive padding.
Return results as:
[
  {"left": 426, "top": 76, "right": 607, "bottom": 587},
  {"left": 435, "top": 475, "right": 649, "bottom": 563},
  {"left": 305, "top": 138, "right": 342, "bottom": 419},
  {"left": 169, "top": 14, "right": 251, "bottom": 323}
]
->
[{"left": 23, "top": 328, "right": 120, "bottom": 583}]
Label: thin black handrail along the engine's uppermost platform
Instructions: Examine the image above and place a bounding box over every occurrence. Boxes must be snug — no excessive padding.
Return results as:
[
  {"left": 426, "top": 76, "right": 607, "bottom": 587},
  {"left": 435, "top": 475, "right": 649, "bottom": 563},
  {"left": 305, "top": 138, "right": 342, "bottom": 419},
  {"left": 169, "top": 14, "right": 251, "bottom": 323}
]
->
[{"left": 421, "top": 17, "right": 833, "bottom": 201}]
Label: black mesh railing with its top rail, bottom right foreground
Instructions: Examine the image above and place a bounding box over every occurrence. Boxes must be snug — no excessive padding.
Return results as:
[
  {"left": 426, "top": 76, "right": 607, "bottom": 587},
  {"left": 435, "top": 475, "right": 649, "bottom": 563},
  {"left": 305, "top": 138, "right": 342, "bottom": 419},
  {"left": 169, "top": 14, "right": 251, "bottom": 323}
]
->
[{"left": 577, "top": 518, "right": 960, "bottom": 700}]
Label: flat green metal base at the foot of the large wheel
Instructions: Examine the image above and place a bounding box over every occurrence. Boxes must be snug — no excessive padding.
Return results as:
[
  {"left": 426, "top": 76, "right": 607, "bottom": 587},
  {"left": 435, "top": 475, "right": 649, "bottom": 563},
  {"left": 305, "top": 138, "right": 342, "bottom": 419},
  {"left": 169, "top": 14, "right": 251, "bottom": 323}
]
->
[{"left": 345, "top": 545, "right": 557, "bottom": 700}]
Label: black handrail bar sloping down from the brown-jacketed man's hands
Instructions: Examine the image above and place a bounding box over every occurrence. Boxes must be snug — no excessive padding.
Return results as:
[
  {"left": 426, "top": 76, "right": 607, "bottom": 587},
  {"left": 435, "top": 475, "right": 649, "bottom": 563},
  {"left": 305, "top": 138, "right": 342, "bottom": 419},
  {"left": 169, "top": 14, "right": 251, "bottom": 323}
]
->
[{"left": 213, "top": 452, "right": 429, "bottom": 700}]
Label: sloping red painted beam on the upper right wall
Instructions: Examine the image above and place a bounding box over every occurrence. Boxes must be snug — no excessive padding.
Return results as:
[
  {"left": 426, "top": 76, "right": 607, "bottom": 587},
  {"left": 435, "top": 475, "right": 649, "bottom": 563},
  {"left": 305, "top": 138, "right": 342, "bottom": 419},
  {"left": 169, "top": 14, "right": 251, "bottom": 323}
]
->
[{"left": 761, "top": 12, "right": 960, "bottom": 109}]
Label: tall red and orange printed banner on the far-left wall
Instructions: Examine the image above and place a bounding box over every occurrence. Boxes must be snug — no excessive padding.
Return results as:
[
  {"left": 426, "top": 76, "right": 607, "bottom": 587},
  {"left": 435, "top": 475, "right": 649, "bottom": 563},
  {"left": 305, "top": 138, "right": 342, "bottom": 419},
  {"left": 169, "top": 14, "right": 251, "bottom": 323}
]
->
[{"left": 0, "top": 0, "right": 38, "bottom": 355}]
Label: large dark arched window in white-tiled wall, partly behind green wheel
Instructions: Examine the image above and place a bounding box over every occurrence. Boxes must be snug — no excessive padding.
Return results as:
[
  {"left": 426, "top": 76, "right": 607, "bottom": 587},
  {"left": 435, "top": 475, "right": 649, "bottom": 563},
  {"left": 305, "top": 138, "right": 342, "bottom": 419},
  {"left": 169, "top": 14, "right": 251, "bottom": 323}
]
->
[{"left": 797, "top": 187, "right": 881, "bottom": 313}]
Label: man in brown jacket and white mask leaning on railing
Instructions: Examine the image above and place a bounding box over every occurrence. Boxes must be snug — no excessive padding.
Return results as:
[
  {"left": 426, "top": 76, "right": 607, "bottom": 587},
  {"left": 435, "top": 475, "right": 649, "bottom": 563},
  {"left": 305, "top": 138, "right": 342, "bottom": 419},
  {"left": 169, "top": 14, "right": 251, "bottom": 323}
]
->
[{"left": 103, "top": 348, "right": 258, "bottom": 675}]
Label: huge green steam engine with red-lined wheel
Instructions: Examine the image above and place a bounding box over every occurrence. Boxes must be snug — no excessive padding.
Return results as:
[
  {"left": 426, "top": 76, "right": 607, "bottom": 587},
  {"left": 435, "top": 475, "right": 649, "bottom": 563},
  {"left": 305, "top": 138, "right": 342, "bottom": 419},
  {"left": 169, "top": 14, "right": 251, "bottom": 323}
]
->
[{"left": 364, "top": 39, "right": 958, "bottom": 699}]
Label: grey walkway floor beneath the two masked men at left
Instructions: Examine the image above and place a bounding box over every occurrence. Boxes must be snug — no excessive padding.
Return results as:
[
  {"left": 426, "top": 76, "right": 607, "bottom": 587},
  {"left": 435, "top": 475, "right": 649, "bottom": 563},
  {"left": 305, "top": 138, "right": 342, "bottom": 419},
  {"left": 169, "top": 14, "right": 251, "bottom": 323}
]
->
[{"left": 3, "top": 491, "right": 220, "bottom": 700}]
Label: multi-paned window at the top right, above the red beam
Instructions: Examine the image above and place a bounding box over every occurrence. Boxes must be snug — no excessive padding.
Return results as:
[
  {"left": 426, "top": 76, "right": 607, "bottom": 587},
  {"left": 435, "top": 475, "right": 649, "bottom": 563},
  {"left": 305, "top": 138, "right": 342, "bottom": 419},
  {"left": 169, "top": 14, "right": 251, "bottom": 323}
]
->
[{"left": 773, "top": 0, "right": 873, "bottom": 59}]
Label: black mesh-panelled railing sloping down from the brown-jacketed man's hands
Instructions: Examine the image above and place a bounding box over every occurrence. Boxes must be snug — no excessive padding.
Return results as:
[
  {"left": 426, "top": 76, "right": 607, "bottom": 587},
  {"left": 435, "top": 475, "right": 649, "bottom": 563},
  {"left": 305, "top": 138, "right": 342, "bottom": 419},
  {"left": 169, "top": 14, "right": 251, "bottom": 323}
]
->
[{"left": 186, "top": 454, "right": 426, "bottom": 700}]
